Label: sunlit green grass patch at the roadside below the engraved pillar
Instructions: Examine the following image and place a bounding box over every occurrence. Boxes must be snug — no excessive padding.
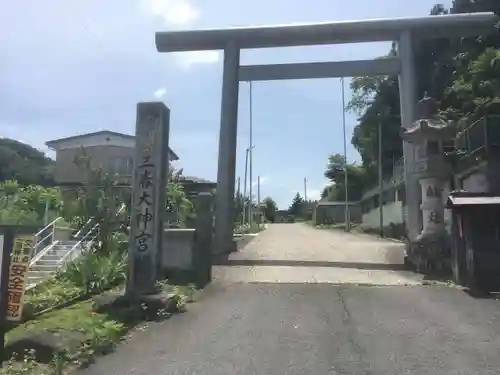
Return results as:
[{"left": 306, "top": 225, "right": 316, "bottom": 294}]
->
[{"left": 0, "top": 282, "right": 196, "bottom": 375}]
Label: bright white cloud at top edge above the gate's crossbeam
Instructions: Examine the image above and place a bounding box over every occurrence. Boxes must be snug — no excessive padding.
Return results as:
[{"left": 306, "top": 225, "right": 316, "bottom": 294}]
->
[{"left": 143, "top": 0, "right": 200, "bottom": 28}]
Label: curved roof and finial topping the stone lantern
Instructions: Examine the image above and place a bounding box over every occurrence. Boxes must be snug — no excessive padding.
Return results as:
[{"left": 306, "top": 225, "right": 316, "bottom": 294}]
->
[{"left": 401, "top": 94, "right": 456, "bottom": 143}]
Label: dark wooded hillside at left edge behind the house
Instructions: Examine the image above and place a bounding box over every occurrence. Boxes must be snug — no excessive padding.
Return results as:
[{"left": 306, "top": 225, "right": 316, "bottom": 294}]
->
[{"left": 0, "top": 138, "right": 54, "bottom": 186}]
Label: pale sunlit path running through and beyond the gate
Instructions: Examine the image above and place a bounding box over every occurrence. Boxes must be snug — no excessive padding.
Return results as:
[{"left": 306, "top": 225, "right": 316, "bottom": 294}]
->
[{"left": 214, "top": 223, "right": 421, "bottom": 285}]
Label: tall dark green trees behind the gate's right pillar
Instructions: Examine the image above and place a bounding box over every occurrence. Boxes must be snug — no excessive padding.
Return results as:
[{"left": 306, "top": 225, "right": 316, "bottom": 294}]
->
[{"left": 322, "top": 0, "right": 500, "bottom": 199}]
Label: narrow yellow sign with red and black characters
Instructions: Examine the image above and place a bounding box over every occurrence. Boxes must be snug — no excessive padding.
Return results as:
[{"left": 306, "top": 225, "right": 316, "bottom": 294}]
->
[{"left": 7, "top": 236, "right": 33, "bottom": 322}]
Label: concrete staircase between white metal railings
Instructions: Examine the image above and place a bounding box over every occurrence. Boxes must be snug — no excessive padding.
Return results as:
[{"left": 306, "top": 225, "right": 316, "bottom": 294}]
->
[{"left": 28, "top": 240, "right": 78, "bottom": 287}]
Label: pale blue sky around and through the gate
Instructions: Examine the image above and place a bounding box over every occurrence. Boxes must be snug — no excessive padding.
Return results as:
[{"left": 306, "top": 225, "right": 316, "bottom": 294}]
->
[{"left": 0, "top": 0, "right": 450, "bottom": 208}]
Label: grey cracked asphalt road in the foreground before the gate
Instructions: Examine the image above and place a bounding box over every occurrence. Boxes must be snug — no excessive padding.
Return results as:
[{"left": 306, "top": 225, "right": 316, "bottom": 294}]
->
[{"left": 82, "top": 283, "right": 500, "bottom": 375}]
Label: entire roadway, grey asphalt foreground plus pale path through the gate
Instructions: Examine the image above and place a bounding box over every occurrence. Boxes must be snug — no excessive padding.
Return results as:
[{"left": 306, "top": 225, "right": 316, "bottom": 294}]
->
[{"left": 78, "top": 224, "right": 500, "bottom": 375}]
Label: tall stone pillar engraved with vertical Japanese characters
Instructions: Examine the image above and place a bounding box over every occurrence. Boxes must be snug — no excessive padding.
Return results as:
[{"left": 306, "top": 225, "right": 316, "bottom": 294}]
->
[{"left": 127, "top": 102, "right": 170, "bottom": 295}]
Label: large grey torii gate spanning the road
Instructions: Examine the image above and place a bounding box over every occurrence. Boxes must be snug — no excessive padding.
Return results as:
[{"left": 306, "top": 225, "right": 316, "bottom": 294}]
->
[{"left": 156, "top": 13, "right": 497, "bottom": 253}]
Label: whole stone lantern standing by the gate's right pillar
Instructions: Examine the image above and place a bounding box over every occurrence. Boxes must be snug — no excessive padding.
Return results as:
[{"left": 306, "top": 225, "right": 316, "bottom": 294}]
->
[{"left": 401, "top": 94, "right": 456, "bottom": 270}]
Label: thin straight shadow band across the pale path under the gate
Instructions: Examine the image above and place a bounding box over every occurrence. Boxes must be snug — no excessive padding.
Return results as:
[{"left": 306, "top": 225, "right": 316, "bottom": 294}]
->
[{"left": 212, "top": 256, "right": 404, "bottom": 271}]
